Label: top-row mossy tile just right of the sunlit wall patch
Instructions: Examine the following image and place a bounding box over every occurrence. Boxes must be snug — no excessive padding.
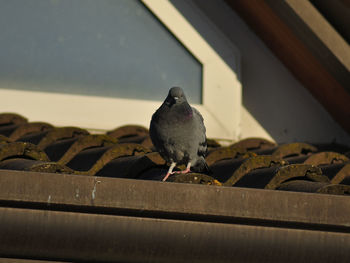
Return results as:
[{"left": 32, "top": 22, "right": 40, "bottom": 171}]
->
[{"left": 272, "top": 142, "right": 317, "bottom": 158}]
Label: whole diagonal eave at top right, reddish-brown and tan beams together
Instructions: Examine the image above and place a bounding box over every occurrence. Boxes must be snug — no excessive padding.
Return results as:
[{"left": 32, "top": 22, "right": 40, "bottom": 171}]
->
[{"left": 226, "top": 0, "right": 350, "bottom": 133}]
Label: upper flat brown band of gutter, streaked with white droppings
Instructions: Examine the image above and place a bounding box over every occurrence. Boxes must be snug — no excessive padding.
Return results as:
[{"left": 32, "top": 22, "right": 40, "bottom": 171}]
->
[{"left": 0, "top": 170, "right": 350, "bottom": 230}]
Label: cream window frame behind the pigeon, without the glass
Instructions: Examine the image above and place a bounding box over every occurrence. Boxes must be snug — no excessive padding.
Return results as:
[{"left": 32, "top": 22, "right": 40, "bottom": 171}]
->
[{"left": 0, "top": 0, "right": 242, "bottom": 140}]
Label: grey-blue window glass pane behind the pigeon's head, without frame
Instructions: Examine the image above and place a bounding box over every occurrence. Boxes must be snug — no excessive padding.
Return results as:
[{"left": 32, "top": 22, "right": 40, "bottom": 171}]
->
[{"left": 0, "top": 0, "right": 202, "bottom": 103}]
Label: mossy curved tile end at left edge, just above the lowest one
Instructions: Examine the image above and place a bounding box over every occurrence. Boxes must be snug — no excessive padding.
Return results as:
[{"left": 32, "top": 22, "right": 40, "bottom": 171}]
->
[{"left": 0, "top": 142, "right": 49, "bottom": 162}]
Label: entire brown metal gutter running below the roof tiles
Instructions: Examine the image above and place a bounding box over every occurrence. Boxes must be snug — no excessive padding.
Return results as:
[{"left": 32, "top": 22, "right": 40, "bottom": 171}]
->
[{"left": 0, "top": 170, "right": 350, "bottom": 262}]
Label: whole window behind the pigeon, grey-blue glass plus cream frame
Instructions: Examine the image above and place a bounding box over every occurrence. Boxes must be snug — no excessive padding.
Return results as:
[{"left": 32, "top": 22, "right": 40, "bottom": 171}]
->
[{"left": 0, "top": 0, "right": 241, "bottom": 139}]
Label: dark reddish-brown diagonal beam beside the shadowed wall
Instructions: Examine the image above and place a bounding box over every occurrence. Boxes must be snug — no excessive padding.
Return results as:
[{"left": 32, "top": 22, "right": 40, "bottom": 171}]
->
[{"left": 226, "top": 0, "right": 350, "bottom": 133}]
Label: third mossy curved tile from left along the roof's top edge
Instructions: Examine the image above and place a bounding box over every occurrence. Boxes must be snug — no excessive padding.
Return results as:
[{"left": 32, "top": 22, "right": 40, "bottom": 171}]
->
[{"left": 38, "top": 127, "right": 89, "bottom": 150}]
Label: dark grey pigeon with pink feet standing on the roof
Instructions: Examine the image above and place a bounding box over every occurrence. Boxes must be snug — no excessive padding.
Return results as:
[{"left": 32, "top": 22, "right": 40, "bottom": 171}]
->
[{"left": 149, "top": 87, "right": 210, "bottom": 181}]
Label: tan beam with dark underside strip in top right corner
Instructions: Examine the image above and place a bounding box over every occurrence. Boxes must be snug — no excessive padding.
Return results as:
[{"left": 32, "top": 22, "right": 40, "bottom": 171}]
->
[{"left": 265, "top": 0, "right": 350, "bottom": 92}]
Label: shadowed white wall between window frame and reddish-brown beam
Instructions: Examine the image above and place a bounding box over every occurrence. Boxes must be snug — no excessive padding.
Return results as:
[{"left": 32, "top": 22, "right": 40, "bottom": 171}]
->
[{"left": 171, "top": 0, "right": 350, "bottom": 145}]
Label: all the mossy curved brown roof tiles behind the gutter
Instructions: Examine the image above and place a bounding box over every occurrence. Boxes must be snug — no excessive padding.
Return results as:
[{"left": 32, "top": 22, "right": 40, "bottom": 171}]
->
[{"left": 0, "top": 113, "right": 350, "bottom": 197}]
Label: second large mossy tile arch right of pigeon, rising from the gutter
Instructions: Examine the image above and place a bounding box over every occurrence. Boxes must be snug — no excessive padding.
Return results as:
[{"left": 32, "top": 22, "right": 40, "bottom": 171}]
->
[{"left": 265, "top": 164, "right": 329, "bottom": 189}]
